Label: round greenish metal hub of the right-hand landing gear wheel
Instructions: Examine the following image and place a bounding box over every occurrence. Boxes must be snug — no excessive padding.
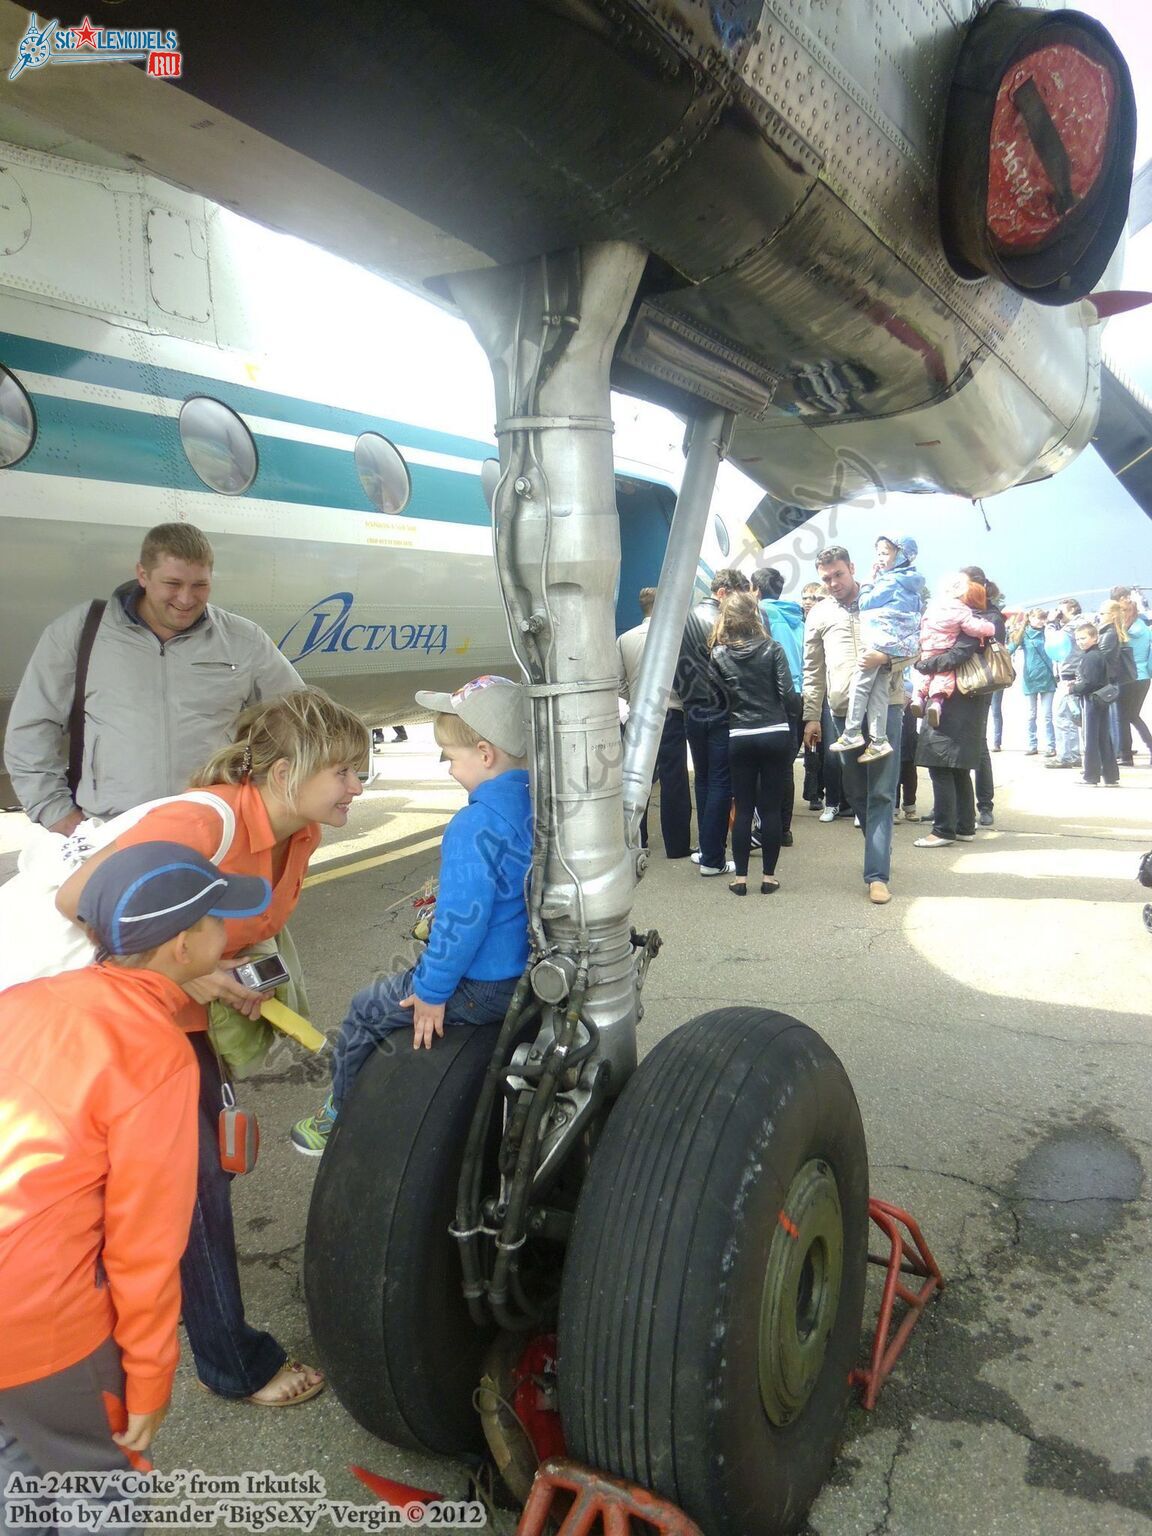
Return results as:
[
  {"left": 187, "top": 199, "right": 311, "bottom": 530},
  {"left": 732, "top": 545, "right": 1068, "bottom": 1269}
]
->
[{"left": 759, "top": 1158, "right": 843, "bottom": 1425}]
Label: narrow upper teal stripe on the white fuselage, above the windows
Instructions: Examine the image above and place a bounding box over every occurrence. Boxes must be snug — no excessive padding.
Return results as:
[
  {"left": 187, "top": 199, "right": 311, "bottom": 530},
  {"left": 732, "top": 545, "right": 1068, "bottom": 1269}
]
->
[{"left": 0, "top": 330, "right": 495, "bottom": 462}]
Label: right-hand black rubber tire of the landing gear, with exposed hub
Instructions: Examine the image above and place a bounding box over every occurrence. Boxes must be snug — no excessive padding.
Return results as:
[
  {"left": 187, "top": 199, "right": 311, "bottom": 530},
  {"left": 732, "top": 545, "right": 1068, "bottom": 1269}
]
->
[{"left": 559, "top": 1008, "right": 868, "bottom": 1536}]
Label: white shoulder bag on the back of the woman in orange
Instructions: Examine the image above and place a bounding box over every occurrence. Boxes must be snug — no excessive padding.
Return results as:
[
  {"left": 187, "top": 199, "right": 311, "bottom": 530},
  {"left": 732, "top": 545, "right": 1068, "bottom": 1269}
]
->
[{"left": 0, "top": 790, "right": 237, "bottom": 992}]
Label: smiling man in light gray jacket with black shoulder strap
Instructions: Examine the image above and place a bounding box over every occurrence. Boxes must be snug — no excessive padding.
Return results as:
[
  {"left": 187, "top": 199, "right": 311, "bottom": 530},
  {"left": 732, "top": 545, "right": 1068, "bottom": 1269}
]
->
[{"left": 5, "top": 522, "right": 304, "bottom": 837}]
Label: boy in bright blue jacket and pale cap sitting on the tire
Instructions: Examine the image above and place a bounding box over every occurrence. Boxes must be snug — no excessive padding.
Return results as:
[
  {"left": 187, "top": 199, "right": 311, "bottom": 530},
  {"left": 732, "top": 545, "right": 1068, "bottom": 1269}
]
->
[{"left": 292, "top": 677, "right": 531, "bottom": 1157}]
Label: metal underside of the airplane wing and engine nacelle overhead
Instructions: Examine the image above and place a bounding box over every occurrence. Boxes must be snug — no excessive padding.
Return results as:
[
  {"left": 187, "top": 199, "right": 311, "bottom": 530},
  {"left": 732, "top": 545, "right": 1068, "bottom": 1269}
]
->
[{"left": 0, "top": 0, "right": 1136, "bottom": 508}]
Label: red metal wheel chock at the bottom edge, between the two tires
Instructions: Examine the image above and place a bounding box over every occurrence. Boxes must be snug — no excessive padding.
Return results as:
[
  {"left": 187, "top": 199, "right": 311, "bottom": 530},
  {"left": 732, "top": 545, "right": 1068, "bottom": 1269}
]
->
[{"left": 516, "top": 1461, "right": 702, "bottom": 1536}]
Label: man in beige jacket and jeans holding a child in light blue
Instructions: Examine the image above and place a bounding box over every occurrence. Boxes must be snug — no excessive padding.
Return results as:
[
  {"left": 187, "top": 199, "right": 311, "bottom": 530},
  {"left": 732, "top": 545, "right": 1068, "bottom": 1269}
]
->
[{"left": 803, "top": 544, "right": 905, "bottom": 906}]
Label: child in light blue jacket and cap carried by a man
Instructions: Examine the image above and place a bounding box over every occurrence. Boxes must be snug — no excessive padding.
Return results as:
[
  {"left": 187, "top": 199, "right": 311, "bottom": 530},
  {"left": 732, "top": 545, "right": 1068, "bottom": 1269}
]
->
[{"left": 828, "top": 535, "right": 925, "bottom": 763}]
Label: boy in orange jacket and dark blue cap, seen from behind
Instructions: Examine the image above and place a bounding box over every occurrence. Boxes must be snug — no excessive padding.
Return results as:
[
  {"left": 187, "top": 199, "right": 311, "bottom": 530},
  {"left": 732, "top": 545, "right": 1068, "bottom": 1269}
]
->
[{"left": 0, "top": 843, "right": 270, "bottom": 1530}]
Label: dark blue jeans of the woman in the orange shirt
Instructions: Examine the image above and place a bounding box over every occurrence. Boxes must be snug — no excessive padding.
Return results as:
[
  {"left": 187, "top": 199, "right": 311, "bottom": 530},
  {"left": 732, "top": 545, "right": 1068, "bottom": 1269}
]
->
[{"left": 180, "top": 1031, "right": 287, "bottom": 1398}]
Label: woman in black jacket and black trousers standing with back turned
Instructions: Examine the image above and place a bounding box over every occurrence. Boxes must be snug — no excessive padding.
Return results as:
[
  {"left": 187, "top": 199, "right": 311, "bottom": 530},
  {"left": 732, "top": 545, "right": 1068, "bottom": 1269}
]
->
[{"left": 711, "top": 591, "right": 800, "bottom": 895}]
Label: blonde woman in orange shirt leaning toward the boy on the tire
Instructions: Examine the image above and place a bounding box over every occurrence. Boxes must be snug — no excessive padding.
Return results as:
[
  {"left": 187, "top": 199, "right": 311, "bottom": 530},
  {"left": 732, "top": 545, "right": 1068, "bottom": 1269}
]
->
[{"left": 57, "top": 688, "right": 369, "bottom": 1407}]
